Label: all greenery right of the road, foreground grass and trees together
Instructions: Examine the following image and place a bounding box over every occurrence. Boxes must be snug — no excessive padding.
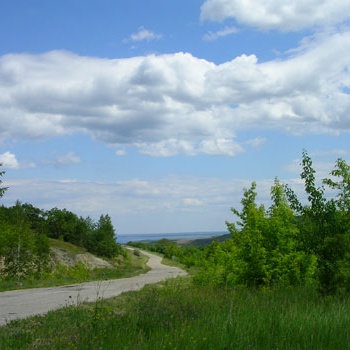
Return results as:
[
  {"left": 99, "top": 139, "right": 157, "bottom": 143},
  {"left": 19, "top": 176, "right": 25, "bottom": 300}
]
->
[{"left": 0, "top": 151, "right": 350, "bottom": 350}]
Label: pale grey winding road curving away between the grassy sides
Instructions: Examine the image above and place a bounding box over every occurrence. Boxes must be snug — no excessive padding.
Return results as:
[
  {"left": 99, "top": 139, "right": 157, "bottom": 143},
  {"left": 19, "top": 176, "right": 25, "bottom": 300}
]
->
[{"left": 0, "top": 252, "right": 186, "bottom": 326}]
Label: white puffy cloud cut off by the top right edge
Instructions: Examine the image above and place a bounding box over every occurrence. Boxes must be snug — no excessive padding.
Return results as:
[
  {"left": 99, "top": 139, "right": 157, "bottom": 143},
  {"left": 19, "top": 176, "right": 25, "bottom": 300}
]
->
[{"left": 201, "top": 0, "right": 350, "bottom": 31}]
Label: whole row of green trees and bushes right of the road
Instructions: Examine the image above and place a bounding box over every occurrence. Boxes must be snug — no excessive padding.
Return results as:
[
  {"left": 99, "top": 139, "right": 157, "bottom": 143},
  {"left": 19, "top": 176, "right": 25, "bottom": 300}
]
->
[{"left": 130, "top": 151, "right": 350, "bottom": 295}]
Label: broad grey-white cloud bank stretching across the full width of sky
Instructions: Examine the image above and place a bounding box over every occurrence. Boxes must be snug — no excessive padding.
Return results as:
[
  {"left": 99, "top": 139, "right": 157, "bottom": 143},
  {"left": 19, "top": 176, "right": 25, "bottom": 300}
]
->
[{"left": 0, "top": 30, "right": 350, "bottom": 156}]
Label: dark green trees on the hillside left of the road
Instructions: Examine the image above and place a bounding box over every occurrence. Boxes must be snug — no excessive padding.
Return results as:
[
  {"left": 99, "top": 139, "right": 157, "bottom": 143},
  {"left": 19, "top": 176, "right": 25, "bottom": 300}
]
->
[{"left": 0, "top": 167, "right": 122, "bottom": 278}]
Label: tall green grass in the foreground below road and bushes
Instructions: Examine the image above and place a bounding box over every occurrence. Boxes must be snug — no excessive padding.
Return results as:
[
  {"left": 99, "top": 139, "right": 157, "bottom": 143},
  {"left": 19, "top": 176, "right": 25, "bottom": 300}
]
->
[{"left": 0, "top": 278, "right": 350, "bottom": 350}]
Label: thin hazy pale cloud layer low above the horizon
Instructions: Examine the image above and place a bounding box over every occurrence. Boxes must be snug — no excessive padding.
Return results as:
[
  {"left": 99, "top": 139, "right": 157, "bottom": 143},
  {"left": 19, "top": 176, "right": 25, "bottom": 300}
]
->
[{"left": 3, "top": 176, "right": 272, "bottom": 233}]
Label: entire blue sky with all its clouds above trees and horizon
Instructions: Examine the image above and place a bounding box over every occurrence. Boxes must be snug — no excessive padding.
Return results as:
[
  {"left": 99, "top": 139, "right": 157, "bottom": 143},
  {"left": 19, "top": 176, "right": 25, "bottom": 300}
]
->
[{"left": 0, "top": 0, "right": 350, "bottom": 236}]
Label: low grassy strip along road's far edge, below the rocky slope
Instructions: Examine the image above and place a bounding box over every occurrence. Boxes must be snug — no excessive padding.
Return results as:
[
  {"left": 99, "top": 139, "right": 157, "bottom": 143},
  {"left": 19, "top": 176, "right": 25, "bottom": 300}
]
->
[{"left": 0, "top": 249, "right": 150, "bottom": 292}]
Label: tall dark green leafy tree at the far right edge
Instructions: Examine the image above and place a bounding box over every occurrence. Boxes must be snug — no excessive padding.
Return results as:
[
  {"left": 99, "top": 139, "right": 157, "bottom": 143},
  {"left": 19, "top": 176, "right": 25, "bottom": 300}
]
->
[{"left": 286, "top": 151, "right": 350, "bottom": 294}]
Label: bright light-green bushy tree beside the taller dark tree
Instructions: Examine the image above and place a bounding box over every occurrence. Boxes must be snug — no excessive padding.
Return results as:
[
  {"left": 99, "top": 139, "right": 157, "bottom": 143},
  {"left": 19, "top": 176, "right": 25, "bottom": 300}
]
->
[{"left": 196, "top": 179, "right": 316, "bottom": 287}]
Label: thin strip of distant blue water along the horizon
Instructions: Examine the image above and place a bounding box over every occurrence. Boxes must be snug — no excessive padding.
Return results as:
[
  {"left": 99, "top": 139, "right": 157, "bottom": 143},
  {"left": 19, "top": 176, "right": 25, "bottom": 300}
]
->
[{"left": 117, "top": 231, "right": 228, "bottom": 244}]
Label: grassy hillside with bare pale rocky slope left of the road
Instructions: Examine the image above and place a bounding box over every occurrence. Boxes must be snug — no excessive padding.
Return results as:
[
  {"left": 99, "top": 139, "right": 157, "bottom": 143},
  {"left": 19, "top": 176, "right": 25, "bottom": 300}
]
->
[{"left": 0, "top": 239, "right": 150, "bottom": 292}]
